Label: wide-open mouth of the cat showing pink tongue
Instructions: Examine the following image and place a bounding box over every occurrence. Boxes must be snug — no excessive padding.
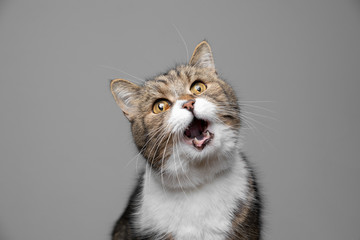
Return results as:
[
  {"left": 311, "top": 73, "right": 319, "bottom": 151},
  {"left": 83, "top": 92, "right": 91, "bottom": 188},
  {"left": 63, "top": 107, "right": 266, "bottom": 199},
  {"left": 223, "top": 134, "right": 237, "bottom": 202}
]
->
[{"left": 184, "top": 117, "right": 214, "bottom": 150}]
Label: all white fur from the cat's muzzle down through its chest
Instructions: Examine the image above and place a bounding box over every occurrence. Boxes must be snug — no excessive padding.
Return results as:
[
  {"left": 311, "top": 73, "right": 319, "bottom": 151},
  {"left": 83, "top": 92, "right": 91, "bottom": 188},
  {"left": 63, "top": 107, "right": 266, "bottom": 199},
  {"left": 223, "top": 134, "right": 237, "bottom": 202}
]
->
[{"left": 135, "top": 97, "right": 249, "bottom": 240}]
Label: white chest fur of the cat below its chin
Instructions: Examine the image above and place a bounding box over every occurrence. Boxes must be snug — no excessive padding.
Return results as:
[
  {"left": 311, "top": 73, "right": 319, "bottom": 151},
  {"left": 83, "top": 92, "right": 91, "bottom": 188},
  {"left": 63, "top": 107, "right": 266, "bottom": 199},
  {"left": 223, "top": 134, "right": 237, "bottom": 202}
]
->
[{"left": 136, "top": 156, "right": 248, "bottom": 240}]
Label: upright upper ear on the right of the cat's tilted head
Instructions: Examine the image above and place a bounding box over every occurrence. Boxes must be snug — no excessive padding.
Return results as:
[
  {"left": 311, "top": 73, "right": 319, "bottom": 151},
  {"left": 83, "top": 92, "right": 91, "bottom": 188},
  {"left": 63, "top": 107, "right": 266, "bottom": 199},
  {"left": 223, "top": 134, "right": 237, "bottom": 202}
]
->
[{"left": 189, "top": 41, "right": 215, "bottom": 70}]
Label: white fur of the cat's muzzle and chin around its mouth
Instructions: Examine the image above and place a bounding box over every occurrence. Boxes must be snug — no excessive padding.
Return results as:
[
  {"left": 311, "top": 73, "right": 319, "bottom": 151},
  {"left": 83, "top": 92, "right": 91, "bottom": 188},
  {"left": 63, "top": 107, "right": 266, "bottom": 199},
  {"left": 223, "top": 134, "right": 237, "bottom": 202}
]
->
[{"left": 166, "top": 97, "right": 241, "bottom": 173}]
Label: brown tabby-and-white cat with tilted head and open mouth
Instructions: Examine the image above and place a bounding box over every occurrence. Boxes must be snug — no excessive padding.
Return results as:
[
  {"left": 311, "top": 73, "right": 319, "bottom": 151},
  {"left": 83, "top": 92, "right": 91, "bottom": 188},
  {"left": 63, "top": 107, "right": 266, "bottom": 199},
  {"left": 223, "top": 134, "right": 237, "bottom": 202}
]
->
[{"left": 110, "top": 41, "right": 262, "bottom": 240}]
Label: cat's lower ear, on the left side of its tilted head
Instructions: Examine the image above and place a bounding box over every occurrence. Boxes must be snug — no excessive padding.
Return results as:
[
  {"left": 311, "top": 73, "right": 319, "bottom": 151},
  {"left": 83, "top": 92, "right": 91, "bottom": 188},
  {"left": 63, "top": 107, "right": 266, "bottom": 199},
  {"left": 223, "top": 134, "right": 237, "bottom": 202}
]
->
[{"left": 110, "top": 79, "right": 140, "bottom": 122}]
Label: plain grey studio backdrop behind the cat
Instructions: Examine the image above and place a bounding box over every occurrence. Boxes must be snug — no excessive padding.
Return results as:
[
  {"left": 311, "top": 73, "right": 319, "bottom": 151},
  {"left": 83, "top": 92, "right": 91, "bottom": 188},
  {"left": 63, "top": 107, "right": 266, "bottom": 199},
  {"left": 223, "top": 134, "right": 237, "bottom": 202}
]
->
[{"left": 0, "top": 0, "right": 360, "bottom": 240}]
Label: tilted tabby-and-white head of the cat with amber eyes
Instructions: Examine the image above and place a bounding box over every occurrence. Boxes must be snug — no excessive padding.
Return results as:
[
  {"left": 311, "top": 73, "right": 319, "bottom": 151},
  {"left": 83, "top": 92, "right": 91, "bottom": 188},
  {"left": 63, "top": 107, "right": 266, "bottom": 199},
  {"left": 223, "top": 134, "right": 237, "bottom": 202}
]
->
[{"left": 111, "top": 41, "right": 240, "bottom": 188}]
